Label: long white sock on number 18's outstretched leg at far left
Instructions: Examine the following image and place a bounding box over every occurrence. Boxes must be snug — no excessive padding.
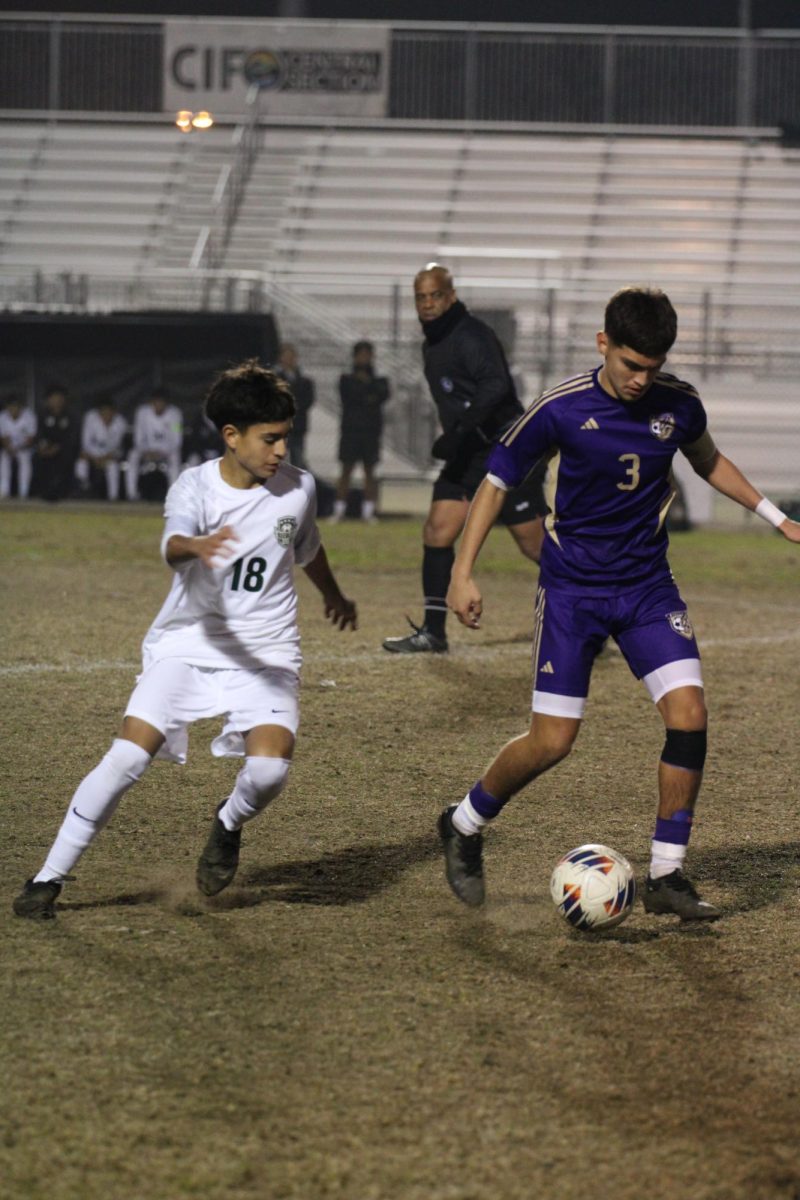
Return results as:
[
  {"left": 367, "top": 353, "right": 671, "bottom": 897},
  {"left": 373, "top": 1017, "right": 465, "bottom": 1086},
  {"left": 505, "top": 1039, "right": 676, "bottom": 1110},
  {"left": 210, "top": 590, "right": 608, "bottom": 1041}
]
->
[{"left": 34, "top": 738, "right": 150, "bottom": 883}]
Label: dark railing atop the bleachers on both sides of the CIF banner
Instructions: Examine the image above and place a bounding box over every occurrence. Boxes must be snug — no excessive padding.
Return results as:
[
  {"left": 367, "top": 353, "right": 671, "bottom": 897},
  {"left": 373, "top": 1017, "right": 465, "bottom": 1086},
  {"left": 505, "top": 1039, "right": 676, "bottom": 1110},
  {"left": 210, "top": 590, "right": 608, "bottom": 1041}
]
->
[{"left": 0, "top": 14, "right": 800, "bottom": 131}]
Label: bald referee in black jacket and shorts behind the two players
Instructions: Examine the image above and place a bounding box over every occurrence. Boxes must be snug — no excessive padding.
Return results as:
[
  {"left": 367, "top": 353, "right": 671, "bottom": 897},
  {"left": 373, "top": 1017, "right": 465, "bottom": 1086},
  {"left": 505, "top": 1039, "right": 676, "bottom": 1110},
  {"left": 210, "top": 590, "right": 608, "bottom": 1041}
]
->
[{"left": 384, "top": 263, "right": 548, "bottom": 654}]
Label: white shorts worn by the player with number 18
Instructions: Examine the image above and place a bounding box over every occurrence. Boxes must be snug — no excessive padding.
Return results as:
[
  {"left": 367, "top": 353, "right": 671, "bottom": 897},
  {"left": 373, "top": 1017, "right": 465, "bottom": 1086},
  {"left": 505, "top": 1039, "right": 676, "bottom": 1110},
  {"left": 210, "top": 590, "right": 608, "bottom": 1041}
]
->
[{"left": 125, "top": 659, "right": 300, "bottom": 763}]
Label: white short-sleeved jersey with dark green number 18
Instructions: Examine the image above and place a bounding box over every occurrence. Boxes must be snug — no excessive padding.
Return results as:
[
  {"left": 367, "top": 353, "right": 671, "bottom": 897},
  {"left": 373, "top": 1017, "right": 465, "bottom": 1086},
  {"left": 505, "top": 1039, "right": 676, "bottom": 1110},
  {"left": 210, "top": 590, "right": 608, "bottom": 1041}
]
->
[{"left": 142, "top": 458, "right": 320, "bottom": 670}]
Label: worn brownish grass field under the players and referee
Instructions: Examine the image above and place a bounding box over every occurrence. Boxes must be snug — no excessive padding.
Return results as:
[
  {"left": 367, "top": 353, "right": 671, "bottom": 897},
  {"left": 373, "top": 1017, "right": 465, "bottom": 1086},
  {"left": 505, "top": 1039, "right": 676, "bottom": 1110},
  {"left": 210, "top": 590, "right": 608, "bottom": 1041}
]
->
[{"left": 0, "top": 504, "right": 800, "bottom": 1200}]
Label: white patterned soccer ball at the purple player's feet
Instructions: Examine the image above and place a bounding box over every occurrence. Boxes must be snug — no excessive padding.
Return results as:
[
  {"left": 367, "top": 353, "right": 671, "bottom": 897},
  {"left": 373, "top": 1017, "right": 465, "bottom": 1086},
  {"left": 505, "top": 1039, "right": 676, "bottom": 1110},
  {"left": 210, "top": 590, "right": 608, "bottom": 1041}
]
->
[{"left": 551, "top": 844, "right": 636, "bottom": 930}]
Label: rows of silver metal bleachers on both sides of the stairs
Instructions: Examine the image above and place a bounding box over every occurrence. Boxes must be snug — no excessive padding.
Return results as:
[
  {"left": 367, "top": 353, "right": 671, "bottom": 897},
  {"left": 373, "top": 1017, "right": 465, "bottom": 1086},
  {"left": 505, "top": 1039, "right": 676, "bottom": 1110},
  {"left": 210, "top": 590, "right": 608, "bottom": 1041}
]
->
[{"left": 0, "top": 121, "right": 800, "bottom": 501}]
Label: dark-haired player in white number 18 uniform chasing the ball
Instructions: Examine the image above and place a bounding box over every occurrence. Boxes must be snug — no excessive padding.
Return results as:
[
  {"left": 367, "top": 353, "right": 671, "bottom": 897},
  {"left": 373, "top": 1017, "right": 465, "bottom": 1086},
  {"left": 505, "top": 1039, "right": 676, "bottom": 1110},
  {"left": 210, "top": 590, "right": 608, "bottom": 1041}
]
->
[{"left": 13, "top": 361, "right": 356, "bottom": 919}]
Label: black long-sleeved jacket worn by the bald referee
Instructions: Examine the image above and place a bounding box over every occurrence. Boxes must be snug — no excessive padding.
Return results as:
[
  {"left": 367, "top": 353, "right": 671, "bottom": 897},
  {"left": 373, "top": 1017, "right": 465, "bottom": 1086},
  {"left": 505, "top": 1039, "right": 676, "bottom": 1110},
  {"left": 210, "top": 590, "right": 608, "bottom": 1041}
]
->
[{"left": 422, "top": 300, "right": 523, "bottom": 458}]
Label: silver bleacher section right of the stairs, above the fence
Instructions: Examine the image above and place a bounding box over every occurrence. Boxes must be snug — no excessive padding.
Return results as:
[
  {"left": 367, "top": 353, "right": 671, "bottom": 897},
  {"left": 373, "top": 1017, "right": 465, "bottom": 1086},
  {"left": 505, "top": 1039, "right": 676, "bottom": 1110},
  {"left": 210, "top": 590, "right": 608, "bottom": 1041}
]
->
[{"left": 261, "top": 131, "right": 800, "bottom": 310}]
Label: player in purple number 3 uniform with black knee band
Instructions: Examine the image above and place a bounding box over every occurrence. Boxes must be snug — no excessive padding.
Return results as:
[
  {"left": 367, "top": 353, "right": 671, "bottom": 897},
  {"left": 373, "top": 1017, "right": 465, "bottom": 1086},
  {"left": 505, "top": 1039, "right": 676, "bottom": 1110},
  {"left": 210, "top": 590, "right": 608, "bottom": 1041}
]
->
[{"left": 439, "top": 288, "right": 800, "bottom": 920}]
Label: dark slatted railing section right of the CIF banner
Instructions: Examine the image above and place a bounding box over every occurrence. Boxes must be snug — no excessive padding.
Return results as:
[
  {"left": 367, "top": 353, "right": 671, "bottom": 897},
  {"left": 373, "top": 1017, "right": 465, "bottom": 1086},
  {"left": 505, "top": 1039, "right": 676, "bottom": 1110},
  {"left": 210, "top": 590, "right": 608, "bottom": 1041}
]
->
[{"left": 390, "top": 26, "right": 767, "bottom": 128}]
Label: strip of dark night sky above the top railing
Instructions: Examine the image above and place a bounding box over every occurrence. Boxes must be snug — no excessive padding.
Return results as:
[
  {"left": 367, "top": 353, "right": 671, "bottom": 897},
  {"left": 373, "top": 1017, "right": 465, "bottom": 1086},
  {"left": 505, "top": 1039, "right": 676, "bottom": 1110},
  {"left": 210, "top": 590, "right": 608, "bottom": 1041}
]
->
[{"left": 9, "top": 0, "right": 800, "bottom": 29}]
